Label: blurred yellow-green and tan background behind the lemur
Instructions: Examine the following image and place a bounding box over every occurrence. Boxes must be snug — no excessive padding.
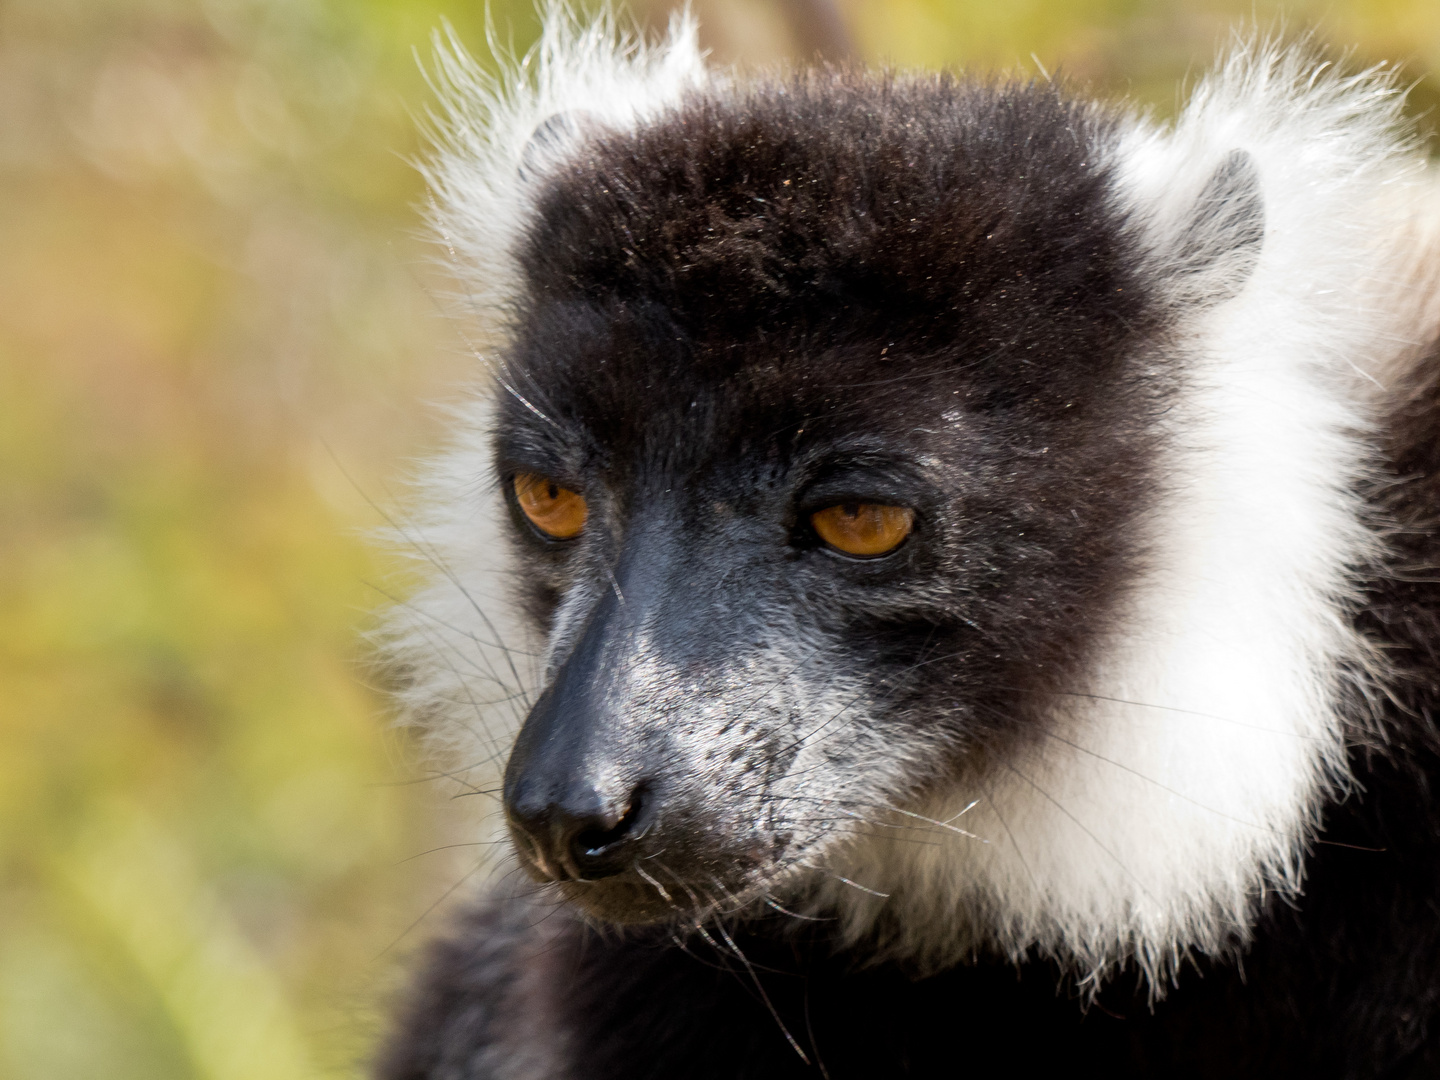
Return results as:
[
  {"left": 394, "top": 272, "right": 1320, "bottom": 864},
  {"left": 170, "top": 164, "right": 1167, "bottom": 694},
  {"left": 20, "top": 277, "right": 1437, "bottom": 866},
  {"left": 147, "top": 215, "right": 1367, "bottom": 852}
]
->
[{"left": 0, "top": 0, "right": 1440, "bottom": 1080}]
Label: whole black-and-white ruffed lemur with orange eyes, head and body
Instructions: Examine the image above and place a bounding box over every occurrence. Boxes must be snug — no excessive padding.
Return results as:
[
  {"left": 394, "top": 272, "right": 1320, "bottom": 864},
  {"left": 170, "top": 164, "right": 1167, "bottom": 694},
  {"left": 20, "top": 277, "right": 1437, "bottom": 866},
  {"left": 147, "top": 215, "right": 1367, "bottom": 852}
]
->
[{"left": 377, "top": 9, "right": 1440, "bottom": 1080}]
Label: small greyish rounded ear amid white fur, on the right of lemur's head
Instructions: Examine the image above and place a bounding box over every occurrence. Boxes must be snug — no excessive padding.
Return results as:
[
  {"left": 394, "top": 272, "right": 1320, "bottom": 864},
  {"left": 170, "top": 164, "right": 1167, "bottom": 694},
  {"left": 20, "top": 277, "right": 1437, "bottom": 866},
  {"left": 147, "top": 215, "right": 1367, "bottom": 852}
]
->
[{"left": 1171, "top": 150, "right": 1264, "bottom": 304}]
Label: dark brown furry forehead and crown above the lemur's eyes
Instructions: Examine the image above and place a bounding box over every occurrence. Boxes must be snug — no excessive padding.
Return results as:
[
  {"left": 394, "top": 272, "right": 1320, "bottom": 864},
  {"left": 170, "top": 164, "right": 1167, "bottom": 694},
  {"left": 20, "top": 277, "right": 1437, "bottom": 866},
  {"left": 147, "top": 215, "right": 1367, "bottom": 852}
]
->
[{"left": 513, "top": 72, "right": 1155, "bottom": 434}]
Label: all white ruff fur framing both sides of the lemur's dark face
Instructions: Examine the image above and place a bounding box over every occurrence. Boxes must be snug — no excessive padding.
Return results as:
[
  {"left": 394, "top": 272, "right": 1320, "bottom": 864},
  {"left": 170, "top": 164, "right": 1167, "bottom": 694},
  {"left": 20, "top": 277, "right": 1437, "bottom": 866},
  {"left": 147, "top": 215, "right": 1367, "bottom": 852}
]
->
[{"left": 393, "top": 9, "right": 1440, "bottom": 986}]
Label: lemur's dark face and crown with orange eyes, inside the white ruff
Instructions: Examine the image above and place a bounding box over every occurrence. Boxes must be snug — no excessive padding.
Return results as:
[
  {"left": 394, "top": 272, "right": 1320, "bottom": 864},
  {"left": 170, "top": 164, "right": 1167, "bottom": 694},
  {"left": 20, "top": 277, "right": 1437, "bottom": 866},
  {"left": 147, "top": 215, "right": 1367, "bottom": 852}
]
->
[{"left": 494, "top": 81, "right": 1174, "bottom": 922}]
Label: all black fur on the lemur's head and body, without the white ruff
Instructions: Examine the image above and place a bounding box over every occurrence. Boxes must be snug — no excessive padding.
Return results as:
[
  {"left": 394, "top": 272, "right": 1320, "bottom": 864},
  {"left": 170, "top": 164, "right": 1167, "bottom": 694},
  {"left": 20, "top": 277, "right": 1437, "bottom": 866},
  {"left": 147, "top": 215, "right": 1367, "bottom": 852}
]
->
[{"left": 377, "top": 75, "right": 1440, "bottom": 1080}]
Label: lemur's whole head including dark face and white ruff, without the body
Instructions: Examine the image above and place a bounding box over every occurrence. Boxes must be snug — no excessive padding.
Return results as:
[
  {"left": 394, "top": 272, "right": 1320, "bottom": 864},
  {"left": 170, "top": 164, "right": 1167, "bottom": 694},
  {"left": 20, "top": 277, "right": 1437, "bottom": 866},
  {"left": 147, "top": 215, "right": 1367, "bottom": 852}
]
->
[{"left": 412, "top": 8, "right": 1416, "bottom": 990}]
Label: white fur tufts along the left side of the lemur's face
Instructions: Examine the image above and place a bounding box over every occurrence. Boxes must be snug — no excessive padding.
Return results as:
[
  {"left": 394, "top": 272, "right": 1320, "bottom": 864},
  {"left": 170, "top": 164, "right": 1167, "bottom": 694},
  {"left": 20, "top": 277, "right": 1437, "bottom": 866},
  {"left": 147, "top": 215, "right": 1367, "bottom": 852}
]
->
[{"left": 387, "top": 0, "right": 710, "bottom": 789}]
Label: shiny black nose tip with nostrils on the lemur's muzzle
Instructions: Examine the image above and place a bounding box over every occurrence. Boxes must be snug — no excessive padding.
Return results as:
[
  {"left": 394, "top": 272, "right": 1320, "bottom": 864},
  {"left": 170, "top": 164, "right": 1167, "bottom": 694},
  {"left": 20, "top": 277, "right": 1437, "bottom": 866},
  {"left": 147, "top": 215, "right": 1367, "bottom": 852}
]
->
[{"left": 505, "top": 788, "right": 645, "bottom": 881}]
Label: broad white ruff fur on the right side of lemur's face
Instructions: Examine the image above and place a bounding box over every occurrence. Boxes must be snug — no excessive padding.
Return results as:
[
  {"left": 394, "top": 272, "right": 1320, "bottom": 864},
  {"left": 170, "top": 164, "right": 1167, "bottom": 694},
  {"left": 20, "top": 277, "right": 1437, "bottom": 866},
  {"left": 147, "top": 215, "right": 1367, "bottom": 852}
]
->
[{"left": 837, "top": 46, "right": 1418, "bottom": 986}]
